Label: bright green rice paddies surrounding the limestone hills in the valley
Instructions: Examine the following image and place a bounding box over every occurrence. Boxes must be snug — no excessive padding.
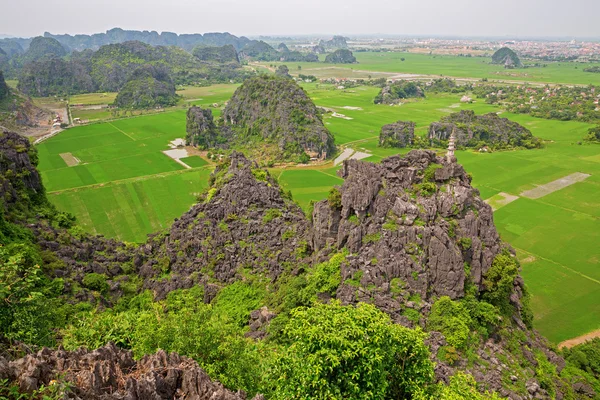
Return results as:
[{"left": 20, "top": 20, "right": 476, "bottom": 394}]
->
[{"left": 38, "top": 72, "right": 600, "bottom": 343}]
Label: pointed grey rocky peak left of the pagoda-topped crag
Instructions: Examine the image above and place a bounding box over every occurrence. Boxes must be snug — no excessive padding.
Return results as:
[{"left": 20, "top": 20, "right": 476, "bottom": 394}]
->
[{"left": 140, "top": 152, "right": 311, "bottom": 298}]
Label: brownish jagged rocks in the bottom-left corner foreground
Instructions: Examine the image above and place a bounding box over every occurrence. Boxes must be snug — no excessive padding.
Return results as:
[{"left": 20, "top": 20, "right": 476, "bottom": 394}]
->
[{"left": 0, "top": 343, "right": 263, "bottom": 400}]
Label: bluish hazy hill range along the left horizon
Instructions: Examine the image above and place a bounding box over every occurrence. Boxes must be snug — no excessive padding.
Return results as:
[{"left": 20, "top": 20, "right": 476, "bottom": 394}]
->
[{"left": 44, "top": 28, "right": 250, "bottom": 51}]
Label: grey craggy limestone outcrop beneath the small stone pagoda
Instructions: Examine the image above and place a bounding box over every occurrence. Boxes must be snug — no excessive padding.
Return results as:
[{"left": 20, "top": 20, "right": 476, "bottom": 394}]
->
[{"left": 313, "top": 150, "right": 503, "bottom": 321}]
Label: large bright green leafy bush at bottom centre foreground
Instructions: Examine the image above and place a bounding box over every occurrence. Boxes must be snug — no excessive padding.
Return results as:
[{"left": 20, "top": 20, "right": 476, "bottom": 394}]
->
[{"left": 267, "top": 301, "right": 433, "bottom": 399}]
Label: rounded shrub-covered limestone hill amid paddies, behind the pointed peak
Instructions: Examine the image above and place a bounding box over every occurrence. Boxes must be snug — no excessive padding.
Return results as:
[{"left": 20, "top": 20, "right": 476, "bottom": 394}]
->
[{"left": 188, "top": 75, "right": 335, "bottom": 161}]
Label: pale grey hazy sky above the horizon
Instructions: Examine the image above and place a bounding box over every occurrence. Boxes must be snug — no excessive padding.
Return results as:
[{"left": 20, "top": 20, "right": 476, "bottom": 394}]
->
[{"left": 0, "top": 0, "right": 600, "bottom": 37}]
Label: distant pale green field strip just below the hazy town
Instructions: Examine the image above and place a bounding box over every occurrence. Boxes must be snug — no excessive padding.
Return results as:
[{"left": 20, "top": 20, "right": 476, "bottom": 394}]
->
[{"left": 262, "top": 52, "right": 600, "bottom": 85}]
